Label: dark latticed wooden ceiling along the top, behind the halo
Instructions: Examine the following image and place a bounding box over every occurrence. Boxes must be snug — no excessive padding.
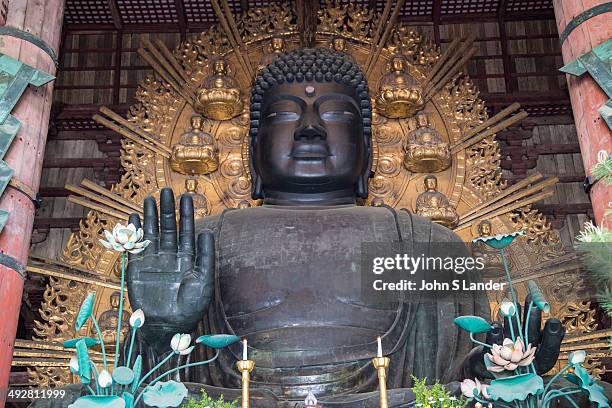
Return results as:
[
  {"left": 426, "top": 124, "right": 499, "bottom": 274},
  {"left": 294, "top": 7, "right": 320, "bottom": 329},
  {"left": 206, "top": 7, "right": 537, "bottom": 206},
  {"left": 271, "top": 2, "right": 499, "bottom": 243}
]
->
[{"left": 64, "top": 0, "right": 553, "bottom": 33}]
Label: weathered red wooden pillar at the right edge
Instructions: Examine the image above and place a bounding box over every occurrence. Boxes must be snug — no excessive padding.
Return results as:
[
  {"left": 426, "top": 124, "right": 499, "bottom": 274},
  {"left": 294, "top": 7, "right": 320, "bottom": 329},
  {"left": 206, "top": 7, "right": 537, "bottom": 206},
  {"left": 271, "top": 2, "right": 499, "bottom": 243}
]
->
[{"left": 553, "top": 0, "right": 612, "bottom": 227}]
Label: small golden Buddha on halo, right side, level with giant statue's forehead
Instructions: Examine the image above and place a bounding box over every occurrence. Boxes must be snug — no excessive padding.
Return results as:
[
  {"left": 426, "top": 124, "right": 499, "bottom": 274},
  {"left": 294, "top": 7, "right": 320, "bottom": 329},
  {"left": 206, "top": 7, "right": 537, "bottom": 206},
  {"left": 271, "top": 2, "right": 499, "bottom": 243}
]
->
[{"left": 375, "top": 55, "right": 424, "bottom": 119}]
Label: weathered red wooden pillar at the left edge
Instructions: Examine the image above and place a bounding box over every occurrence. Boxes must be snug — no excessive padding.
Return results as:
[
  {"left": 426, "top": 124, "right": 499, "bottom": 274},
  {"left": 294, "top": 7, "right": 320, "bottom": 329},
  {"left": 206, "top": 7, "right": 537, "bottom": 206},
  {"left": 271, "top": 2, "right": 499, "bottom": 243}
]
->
[{"left": 0, "top": 0, "right": 64, "bottom": 398}]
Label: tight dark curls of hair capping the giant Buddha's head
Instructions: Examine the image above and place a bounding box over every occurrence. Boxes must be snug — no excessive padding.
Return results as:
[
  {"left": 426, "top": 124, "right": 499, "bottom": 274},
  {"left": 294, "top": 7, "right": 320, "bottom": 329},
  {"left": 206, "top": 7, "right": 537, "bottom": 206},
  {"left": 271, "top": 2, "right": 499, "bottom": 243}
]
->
[{"left": 250, "top": 48, "right": 372, "bottom": 137}]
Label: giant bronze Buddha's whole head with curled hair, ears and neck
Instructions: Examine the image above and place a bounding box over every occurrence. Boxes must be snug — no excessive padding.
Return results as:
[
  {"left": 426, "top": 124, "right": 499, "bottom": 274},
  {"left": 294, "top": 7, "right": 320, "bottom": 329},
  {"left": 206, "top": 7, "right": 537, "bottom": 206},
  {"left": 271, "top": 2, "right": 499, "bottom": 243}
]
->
[{"left": 250, "top": 48, "right": 372, "bottom": 204}]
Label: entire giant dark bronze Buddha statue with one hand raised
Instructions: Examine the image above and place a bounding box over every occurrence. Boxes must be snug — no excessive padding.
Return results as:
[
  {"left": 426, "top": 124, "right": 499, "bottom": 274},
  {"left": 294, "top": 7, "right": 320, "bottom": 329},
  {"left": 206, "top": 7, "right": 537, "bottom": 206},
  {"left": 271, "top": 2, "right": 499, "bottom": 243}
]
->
[{"left": 128, "top": 49, "right": 560, "bottom": 407}]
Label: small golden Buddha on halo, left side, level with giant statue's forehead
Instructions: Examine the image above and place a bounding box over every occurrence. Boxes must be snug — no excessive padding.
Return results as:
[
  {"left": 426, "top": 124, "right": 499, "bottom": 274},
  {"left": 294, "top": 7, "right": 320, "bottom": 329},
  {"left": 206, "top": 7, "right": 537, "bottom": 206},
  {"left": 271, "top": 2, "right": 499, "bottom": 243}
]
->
[{"left": 194, "top": 58, "right": 243, "bottom": 120}]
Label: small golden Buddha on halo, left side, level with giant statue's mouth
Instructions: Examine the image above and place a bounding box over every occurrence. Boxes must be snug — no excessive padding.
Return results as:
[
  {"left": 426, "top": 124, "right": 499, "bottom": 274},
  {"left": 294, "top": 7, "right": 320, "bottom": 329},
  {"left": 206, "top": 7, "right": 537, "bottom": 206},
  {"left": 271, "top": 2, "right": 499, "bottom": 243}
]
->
[{"left": 170, "top": 115, "right": 219, "bottom": 175}]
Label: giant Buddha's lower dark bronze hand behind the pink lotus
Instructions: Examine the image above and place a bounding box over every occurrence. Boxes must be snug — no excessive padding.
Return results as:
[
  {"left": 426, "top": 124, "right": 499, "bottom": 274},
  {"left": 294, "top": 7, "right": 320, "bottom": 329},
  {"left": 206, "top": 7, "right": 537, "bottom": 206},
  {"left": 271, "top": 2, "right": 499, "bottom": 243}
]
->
[{"left": 463, "top": 296, "right": 565, "bottom": 379}]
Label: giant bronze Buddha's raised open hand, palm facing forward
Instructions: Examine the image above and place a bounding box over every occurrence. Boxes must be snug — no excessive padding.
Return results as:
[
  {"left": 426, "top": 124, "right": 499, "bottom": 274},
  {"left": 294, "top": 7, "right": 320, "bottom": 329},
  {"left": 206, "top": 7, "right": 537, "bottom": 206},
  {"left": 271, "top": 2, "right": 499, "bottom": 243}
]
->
[{"left": 127, "top": 188, "right": 215, "bottom": 352}]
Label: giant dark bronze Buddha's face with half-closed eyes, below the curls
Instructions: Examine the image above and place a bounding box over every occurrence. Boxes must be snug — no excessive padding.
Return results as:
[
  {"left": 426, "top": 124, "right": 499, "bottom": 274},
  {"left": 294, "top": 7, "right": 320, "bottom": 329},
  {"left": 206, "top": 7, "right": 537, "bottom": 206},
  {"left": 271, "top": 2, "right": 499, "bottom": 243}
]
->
[{"left": 254, "top": 81, "right": 368, "bottom": 195}]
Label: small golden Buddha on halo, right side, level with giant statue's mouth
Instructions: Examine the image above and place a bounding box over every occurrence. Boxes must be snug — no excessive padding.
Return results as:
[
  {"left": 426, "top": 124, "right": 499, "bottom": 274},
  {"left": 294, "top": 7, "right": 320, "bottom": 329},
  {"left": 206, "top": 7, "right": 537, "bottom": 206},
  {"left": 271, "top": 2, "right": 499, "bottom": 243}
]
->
[{"left": 404, "top": 112, "right": 452, "bottom": 173}]
